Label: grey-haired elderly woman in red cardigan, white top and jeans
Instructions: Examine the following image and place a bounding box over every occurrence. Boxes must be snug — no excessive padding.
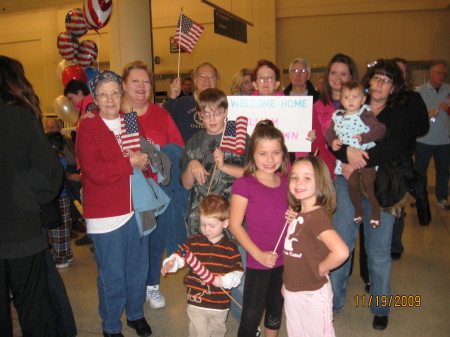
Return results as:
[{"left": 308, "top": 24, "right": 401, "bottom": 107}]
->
[{"left": 77, "top": 71, "right": 151, "bottom": 337}]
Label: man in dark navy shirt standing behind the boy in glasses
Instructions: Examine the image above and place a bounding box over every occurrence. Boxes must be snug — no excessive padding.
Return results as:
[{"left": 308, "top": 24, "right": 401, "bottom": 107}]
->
[{"left": 164, "top": 62, "right": 219, "bottom": 143}]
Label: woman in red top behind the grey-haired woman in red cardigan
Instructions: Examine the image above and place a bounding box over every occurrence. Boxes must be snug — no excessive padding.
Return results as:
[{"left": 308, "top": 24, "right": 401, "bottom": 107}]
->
[{"left": 122, "top": 61, "right": 184, "bottom": 309}]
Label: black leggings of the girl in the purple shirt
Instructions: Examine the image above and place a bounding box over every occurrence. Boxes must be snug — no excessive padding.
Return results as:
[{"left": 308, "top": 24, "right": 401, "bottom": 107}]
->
[{"left": 238, "top": 266, "right": 284, "bottom": 337}]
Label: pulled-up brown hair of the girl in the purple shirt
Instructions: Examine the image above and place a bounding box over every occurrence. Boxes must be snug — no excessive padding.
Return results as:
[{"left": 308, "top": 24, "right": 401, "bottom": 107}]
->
[{"left": 244, "top": 119, "right": 289, "bottom": 177}]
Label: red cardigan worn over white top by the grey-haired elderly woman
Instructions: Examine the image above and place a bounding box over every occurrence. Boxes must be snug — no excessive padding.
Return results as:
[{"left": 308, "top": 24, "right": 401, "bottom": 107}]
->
[{"left": 76, "top": 114, "right": 133, "bottom": 219}]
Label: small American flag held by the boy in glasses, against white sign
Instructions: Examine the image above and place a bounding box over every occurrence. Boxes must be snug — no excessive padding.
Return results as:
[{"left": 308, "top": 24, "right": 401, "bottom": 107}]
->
[{"left": 220, "top": 116, "right": 248, "bottom": 154}]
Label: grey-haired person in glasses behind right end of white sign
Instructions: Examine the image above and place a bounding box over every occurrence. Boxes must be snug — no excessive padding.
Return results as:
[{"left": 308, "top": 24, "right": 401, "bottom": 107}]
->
[{"left": 284, "top": 58, "right": 319, "bottom": 103}]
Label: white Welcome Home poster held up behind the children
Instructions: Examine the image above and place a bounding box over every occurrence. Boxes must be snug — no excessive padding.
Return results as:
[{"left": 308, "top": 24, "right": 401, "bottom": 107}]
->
[{"left": 228, "top": 96, "right": 313, "bottom": 152}]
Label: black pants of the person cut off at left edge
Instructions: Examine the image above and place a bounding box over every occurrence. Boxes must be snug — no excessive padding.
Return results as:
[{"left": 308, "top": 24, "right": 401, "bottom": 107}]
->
[{"left": 0, "top": 250, "right": 57, "bottom": 337}]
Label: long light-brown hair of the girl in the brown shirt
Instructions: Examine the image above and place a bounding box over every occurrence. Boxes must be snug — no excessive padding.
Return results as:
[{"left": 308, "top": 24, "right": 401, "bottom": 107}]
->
[{"left": 287, "top": 155, "right": 336, "bottom": 213}]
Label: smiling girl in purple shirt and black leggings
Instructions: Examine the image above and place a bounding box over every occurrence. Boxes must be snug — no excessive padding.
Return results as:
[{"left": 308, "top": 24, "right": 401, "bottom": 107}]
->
[{"left": 230, "top": 120, "right": 296, "bottom": 337}]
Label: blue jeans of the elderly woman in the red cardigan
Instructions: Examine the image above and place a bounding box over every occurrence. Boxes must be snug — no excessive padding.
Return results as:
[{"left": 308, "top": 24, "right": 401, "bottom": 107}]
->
[{"left": 89, "top": 215, "right": 149, "bottom": 333}]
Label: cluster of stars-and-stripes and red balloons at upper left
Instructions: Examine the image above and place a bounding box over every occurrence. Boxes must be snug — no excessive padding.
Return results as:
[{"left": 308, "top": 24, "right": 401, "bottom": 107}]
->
[{"left": 56, "top": 0, "right": 112, "bottom": 86}]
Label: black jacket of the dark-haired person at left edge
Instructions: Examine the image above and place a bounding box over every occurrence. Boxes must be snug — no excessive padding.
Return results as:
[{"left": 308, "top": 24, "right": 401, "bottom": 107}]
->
[{"left": 0, "top": 98, "right": 63, "bottom": 259}]
